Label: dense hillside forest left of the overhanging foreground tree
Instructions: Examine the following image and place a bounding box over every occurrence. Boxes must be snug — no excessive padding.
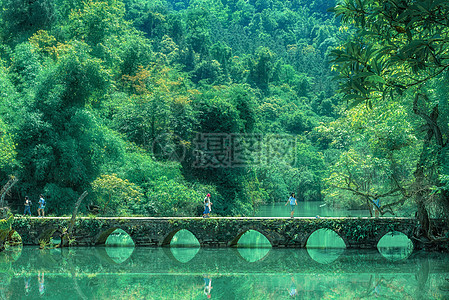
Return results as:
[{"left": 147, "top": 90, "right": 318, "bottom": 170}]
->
[{"left": 0, "top": 0, "right": 346, "bottom": 215}]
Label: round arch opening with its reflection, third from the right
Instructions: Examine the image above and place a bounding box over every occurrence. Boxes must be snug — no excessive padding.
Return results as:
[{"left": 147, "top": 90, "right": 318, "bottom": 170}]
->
[{"left": 237, "top": 230, "right": 271, "bottom": 262}]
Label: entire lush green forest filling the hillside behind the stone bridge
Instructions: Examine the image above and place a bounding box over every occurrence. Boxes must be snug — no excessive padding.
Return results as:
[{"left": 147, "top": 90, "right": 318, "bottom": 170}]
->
[{"left": 0, "top": 0, "right": 449, "bottom": 227}]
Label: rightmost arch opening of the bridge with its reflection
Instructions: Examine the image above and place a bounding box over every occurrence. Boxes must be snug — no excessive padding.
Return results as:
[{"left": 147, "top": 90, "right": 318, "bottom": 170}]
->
[{"left": 377, "top": 231, "right": 413, "bottom": 261}]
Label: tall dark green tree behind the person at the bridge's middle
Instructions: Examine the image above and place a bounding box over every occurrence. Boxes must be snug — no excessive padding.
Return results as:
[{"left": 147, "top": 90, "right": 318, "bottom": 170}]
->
[{"left": 183, "top": 85, "right": 255, "bottom": 214}]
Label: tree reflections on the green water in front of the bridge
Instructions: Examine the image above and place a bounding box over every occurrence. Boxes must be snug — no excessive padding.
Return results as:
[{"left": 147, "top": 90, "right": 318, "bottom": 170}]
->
[{"left": 0, "top": 248, "right": 449, "bottom": 299}]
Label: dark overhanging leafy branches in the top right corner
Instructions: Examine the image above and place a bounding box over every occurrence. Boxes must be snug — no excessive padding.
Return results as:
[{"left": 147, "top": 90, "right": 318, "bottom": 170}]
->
[{"left": 331, "top": 0, "right": 449, "bottom": 103}]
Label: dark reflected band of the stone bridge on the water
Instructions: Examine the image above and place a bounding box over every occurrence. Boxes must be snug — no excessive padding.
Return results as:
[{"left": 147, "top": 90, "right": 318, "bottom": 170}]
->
[{"left": 0, "top": 246, "right": 440, "bottom": 273}]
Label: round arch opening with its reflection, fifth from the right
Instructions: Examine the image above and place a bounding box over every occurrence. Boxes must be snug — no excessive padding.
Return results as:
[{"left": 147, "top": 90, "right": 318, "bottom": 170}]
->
[{"left": 105, "top": 228, "right": 134, "bottom": 264}]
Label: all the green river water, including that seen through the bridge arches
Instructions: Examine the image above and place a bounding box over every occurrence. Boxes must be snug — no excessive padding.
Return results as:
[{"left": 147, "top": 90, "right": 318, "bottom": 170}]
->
[{"left": 0, "top": 204, "right": 449, "bottom": 299}]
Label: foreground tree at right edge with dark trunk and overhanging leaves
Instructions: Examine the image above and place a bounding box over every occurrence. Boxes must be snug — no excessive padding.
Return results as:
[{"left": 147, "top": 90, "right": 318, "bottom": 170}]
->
[{"left": 332, "top": 0, "right": 449, "bottom": 236}]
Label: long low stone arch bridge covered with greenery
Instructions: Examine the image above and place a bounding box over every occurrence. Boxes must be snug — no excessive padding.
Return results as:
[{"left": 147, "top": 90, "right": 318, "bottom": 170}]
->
[{"left": 12, "top": 217, "right": 428, "bottom": 249}]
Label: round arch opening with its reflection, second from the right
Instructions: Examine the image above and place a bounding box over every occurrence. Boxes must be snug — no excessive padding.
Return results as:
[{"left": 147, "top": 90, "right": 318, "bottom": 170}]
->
[{"left": 306, "top": 228, "right": 346, "bottom": 264}]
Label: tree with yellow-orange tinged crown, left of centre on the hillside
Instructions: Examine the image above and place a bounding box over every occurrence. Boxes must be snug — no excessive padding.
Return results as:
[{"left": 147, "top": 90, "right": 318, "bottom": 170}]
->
[{"left": 110, "top": 62, "right": 193, "bottom": 150}]
